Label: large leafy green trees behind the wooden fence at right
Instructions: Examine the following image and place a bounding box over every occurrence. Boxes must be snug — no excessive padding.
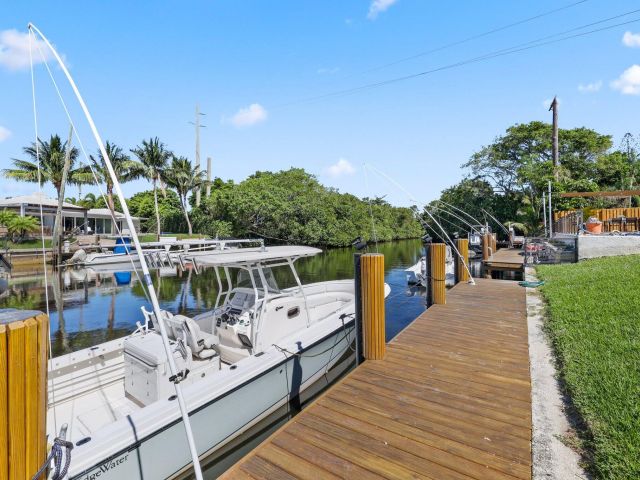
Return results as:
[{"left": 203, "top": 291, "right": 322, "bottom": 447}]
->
[{"left": 424, "top": 121, "right": 640, "bottom": 238}]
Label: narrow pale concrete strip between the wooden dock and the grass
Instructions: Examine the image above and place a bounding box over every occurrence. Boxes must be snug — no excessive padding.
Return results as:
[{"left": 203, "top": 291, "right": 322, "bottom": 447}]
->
[{"left": 526, "top": 268, "right": 589, "bottom": 480}]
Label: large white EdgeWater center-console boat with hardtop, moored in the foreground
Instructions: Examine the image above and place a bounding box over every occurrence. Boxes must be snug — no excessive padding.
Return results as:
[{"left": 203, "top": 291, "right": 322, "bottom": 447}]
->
[{"left": 47, "top": 246, "right": 380, "bottom": 480}]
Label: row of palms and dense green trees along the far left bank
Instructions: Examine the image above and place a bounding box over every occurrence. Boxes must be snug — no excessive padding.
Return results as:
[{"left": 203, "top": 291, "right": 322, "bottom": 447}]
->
[{"left": 3, "top": 135, "right": 422, "bottom": 246}]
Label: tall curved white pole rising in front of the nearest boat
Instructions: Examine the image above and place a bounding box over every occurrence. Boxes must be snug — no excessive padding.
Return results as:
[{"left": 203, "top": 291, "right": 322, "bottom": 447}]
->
[{"left": 27, "top": 23, "right": 202, "bottom": 480}]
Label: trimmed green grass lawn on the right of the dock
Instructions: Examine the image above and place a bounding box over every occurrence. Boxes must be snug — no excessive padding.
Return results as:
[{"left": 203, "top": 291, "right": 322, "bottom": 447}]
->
[{"left": 538, "top": 255, "right": 640, "bottom": 479}]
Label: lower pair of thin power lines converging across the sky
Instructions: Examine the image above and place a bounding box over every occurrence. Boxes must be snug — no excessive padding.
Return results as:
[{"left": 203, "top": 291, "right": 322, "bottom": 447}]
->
[{"left": 272, "top": 9, "right": 640, "bottom": 109}]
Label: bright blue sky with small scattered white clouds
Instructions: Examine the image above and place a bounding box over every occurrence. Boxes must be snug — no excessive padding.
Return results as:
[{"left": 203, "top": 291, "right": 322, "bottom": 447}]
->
[{"left": 0, "top": 0, "right": 640, "bottom": 208}]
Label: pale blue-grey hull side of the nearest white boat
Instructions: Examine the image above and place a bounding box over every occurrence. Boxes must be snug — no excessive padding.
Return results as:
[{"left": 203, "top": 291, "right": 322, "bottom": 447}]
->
[{"left": 69, "top": 322, "right": 354, "bottom": 480}]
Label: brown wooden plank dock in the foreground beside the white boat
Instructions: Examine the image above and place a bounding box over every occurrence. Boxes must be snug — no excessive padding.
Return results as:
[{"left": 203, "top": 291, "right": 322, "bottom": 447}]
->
[{"left": 221, "top": 278, "right": 531, "bottom": 480}]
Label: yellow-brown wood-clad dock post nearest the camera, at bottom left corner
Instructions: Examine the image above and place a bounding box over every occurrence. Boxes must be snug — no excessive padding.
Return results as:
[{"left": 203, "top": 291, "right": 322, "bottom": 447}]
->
[{"left": 0, "top": 310, "right": 49, "bottom": 480}]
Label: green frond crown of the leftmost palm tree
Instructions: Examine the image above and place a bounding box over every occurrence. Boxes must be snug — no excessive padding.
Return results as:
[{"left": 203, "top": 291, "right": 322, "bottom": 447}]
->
[{"left": 2, "top": 135, "right": 92, "bottom": 197}]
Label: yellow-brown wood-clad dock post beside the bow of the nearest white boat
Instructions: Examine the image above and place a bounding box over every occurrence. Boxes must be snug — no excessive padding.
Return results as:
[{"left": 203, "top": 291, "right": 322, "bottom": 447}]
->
[{"left": 360, "top": 253, "right": 386, "bottom": 360}]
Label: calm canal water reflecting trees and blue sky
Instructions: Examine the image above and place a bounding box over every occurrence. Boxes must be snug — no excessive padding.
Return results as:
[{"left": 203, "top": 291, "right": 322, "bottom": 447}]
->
[{"left": 0, "top": 239, "right": 460, "bottom": 356}]
